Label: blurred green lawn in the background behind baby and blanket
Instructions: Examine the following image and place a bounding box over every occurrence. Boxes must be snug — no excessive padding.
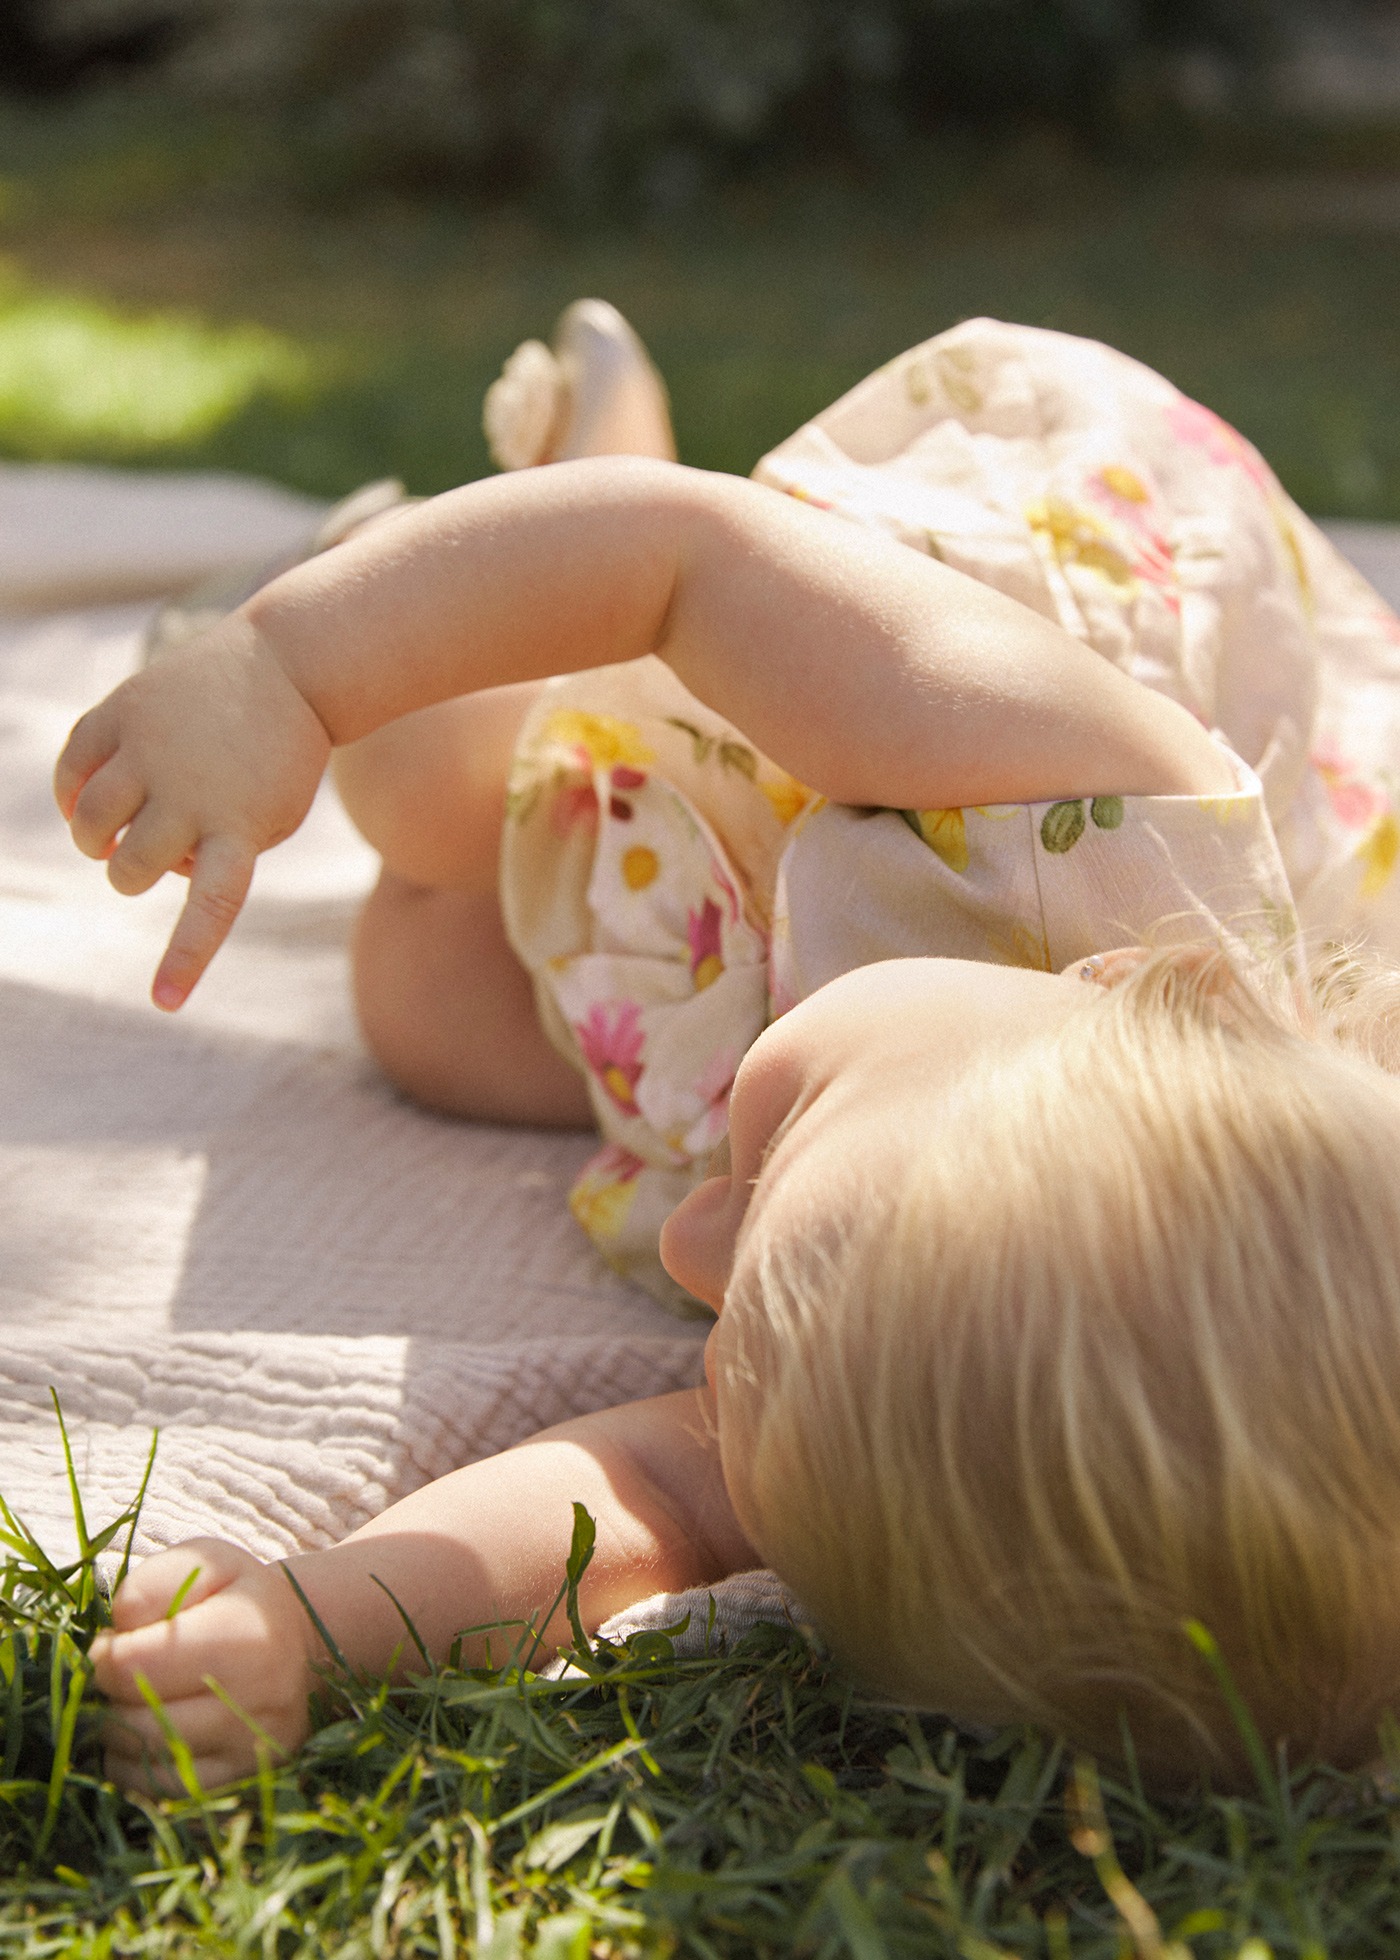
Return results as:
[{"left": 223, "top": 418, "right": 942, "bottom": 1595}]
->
[{"left": 0, "top": 102, "right": 1400, "bottom": 519}]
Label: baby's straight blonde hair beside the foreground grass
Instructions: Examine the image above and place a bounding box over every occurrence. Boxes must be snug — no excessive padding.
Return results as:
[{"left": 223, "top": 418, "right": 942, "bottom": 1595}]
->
[{"left": 716, "top": 953, "right": 1400, "bottom": 1782}]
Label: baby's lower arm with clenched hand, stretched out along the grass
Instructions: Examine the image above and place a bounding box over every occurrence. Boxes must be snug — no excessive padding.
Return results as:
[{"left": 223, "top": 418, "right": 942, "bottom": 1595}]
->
[{"left": 94, "top": 1390, "right": 757, "bottom": 1788}]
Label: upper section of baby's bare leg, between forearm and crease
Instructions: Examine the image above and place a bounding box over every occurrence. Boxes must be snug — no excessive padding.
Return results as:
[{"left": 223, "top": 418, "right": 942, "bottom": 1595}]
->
[{"left": 333, "top": 680, "right": 541, "bottom": 892}]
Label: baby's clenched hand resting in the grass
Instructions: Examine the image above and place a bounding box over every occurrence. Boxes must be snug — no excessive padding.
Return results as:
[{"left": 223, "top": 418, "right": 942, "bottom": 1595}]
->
[{"left": 92, "top": 1539, "right": 320, "bottom": 1791}]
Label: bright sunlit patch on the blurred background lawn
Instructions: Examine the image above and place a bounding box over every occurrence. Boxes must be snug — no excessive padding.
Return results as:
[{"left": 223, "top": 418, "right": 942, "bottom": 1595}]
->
[{"left": 0, "top": 268, "right": 318, "bottom": 459}]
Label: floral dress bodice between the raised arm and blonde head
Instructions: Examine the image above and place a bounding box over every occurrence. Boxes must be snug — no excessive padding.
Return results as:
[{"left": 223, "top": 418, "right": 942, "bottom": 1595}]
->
[{"left": 771, "top": 736, "right": 1298, "bottom": 1013}]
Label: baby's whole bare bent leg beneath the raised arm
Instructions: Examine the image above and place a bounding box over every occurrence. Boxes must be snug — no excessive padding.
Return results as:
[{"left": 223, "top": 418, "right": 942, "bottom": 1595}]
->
[{"left": 333, "top": 684, "right": 592, "bottom": 1129}]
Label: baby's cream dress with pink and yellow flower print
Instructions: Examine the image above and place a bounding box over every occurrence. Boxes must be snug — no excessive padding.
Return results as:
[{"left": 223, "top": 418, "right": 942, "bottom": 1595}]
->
[{"left": 502, "top": 321, "right": 1400, "bottom": 1311}]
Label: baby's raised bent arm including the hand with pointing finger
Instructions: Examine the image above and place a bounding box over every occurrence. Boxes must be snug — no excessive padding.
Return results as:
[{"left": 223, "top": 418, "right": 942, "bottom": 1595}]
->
[{"left": 55, "top": 459, "right": 1233, "bottom": 1005}]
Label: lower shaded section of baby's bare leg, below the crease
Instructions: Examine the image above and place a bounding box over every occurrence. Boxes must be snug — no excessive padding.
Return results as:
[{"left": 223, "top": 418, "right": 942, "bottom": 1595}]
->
[{"left": 353, "top": 870, "right": 592, "bottom": 1129}]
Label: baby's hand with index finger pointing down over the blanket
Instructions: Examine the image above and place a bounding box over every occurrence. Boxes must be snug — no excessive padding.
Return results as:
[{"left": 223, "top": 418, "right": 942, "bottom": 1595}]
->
[{"left": 53, "top": 613, "right": 331, "bottom": 1009}]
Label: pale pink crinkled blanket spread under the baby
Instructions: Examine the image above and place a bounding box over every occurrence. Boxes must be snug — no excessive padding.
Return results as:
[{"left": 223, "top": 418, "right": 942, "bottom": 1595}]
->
[{"left": 0, "top": 466, "right": 704, "bottom": 1556}]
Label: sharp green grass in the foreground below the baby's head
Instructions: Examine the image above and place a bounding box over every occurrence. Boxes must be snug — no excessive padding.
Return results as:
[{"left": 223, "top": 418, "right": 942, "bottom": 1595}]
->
[{"left": 0, "top": 1419, "right": 1400, "bottom": 1960}]
